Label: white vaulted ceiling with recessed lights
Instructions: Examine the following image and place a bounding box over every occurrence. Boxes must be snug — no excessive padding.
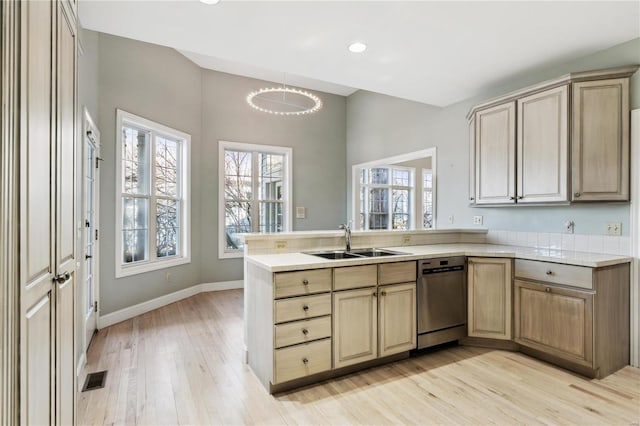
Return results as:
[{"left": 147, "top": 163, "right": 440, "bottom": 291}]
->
[{"left": 79, "top": 0, "right": 640, "bottom": 106}]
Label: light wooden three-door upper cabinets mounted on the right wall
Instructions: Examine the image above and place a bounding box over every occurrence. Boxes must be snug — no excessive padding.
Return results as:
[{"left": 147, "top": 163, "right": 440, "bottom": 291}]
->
[{"left": 468, "top": 65, "right": 638, "bottom": 205}]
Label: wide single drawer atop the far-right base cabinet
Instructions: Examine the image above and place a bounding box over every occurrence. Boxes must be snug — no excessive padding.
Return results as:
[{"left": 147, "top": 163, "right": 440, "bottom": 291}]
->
[{"left": 515, "top": 259, "right": 593, "bottom": 289}]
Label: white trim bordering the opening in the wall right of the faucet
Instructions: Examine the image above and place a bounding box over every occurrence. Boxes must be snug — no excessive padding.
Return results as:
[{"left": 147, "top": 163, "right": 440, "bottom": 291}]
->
[{"left": 351, "top": 147, "right": 438, "bottom": 229}]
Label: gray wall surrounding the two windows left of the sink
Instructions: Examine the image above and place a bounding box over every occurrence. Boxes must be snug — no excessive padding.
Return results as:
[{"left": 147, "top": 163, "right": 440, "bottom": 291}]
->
[{"left": 91, "top": 33, "right": 346, "bottom": 315}]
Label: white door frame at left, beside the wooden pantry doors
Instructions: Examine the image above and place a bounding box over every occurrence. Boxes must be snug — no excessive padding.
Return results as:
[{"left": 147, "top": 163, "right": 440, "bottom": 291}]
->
[{"left": 80, "top": 107, "right": 100, "bottom": 357}]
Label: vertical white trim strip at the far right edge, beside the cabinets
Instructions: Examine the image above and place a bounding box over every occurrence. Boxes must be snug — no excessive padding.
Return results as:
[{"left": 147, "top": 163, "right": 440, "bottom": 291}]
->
[{"left": 630, "top": 109, "right": 640, "bottom": 367}]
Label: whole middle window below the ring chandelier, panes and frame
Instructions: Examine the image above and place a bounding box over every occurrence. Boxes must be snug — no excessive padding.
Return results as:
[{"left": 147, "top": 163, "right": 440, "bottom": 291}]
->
[{"left": 219, "top": 141, "right": 291, "bottom": 258}]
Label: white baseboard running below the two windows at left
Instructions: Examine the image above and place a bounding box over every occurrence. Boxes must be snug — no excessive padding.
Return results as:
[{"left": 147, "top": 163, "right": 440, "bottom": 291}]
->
[{"left": 98, "top": 280, "right": 244, "bottom": 328}]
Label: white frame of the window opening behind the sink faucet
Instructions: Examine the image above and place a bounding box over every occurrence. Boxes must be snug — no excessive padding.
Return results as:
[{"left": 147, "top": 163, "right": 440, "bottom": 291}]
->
[{"left": 351, "top": 147, "right": 438, "bottom": 231}]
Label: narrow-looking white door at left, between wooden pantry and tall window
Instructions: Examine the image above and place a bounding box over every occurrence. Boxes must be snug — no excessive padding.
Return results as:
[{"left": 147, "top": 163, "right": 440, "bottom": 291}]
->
[{"left": 82, "top": 109, "right": 100, "bottom": 351}]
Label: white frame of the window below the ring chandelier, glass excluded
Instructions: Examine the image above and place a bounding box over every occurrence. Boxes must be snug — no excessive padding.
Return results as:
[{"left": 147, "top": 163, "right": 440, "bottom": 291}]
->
[{"left": 218, "top": 140, "right": 293, "bottom": 259}]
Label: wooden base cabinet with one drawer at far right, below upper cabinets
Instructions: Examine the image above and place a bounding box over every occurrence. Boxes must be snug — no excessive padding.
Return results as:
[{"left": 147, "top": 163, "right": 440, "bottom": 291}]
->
[{"left": 514, "top": 259, "right": 629, "bottom": 378}]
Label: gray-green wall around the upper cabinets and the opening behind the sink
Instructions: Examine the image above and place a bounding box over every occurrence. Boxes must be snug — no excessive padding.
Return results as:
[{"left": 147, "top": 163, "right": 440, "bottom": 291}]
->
[{"left": 347, "top": 39, "right": 640, "bottom": 236}]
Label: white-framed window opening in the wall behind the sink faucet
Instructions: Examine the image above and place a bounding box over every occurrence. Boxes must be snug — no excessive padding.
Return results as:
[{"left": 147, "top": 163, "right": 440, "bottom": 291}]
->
[{"left": 351, "top": 148, "right": 436, "bottom": 230}]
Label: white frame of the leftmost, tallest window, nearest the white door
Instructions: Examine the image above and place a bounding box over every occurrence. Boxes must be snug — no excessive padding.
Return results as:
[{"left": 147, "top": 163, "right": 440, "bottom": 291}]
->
[{"left": 115, "top": 109, "right": 191, "bottom": 278}]
